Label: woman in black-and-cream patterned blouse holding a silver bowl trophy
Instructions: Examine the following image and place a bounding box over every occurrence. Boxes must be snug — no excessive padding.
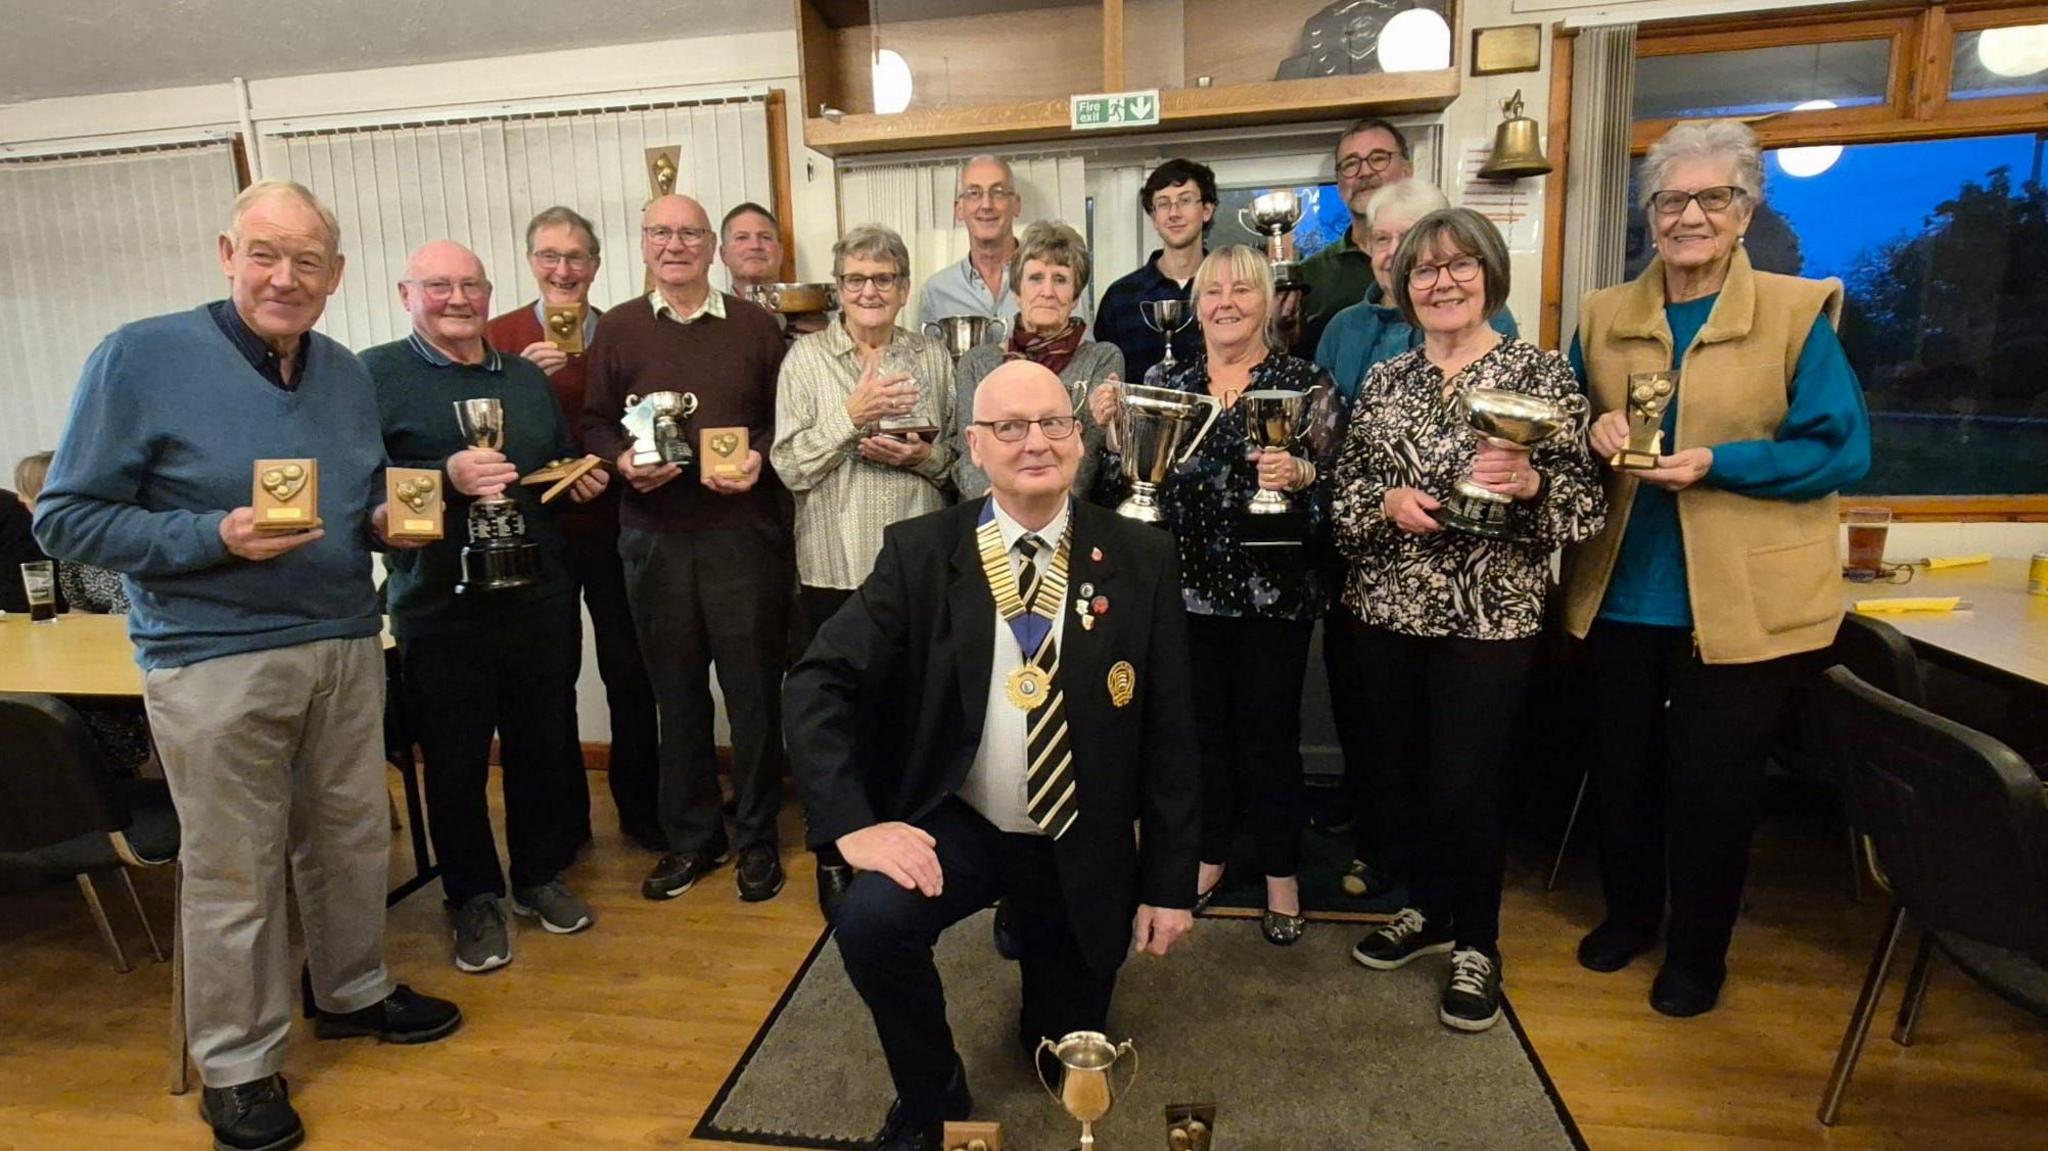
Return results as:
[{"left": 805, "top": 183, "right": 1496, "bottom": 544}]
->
[{"left": 1335, "top": 209, "right": 1606, "bottom": 1030}]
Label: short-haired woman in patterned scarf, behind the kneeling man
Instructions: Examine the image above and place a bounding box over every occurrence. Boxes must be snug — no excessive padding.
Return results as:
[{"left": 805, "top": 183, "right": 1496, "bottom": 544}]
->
[{"left": 946, "top": 219, "right": 1124, "bottom": 500}]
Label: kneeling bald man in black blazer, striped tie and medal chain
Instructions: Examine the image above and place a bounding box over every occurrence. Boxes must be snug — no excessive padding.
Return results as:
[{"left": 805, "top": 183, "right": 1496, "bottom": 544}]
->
[{"left": 784, "top": 360, "right": 1200, "bottom": 1151}]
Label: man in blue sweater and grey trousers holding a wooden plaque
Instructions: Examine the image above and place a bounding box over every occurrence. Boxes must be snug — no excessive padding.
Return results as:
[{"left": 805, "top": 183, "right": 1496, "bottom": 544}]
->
[{"left": 35, "top": 180, "right": 463, "bottom": 1151}]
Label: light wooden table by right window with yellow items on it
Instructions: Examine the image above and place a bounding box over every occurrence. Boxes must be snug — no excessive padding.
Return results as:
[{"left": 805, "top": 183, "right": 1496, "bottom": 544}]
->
[{"left": 1841, "top": 559, "right": 2048, "bottom": 686}]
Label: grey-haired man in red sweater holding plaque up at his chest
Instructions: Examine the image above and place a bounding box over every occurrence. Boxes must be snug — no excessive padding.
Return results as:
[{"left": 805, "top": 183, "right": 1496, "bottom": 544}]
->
[{"left": 483, "top": 207, "right": 668, "bottom": 852}]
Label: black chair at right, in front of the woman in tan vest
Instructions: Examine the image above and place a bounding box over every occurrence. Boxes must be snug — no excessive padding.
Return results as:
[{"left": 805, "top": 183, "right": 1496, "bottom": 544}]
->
[{"left": 1821, "top": 668, "right": 2048, "bottom": 1126}]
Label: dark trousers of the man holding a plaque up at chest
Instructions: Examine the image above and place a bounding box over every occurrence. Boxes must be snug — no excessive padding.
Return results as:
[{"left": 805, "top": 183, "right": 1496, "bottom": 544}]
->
[{"left": 563, "top": 530, "right": 662, "bottom": 840}]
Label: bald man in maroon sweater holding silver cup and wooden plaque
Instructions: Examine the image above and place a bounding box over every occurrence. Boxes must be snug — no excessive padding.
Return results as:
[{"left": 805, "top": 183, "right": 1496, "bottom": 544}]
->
[{"left": 582, "top": 197, "right": 795, "bottom": 901}]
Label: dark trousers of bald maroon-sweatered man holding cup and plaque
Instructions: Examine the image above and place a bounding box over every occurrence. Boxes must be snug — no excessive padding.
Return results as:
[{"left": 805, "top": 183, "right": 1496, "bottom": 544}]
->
[{"left": 618, "top": 520, "right": 788, "bottom": 854}]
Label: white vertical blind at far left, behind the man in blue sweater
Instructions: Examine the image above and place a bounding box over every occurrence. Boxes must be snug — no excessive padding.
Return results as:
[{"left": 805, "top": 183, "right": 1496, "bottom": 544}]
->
[{"left": 0, "top": 143, "right": 236, "bottom": 469}]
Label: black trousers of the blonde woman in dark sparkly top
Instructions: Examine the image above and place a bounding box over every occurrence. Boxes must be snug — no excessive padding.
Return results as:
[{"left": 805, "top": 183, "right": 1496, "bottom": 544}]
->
[{"left": 1188, "top": 614, "right": 1315, "bottom": 877}]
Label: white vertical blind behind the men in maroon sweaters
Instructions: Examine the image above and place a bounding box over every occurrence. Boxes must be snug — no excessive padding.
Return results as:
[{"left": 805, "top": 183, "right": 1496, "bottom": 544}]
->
[{"left": 262, "top": 98, "right": 774, "bottom": 350}]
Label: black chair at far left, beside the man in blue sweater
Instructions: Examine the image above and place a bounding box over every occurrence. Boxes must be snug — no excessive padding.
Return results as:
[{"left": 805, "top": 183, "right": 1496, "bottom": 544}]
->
[{"left": 0, "top": 692, "right": 186, "bottom": 1094}]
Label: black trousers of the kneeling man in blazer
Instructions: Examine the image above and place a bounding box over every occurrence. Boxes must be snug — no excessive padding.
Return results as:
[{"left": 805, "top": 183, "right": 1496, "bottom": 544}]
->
[{"left": 834, "top": 799, "right": 1137, "bottom": 1118}]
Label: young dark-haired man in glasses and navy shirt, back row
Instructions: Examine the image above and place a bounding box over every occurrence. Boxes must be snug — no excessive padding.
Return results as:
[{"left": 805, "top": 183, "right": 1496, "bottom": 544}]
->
[{"left": 1096, "top": 160, "right": 1217, "bottom": 383}]
